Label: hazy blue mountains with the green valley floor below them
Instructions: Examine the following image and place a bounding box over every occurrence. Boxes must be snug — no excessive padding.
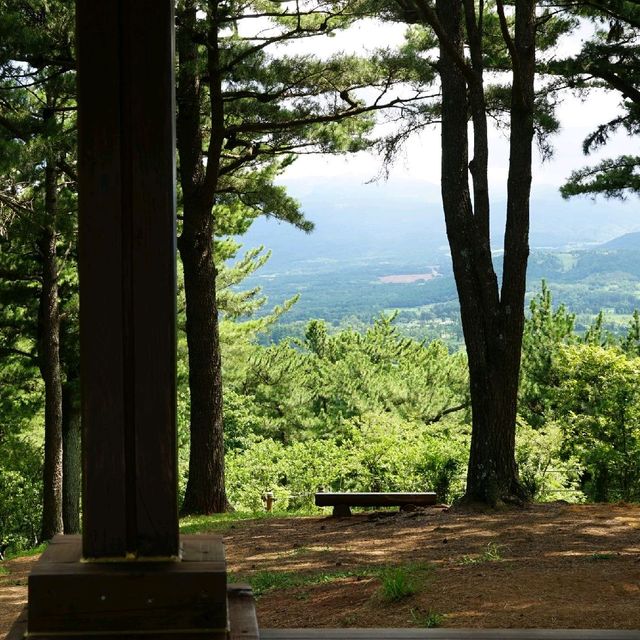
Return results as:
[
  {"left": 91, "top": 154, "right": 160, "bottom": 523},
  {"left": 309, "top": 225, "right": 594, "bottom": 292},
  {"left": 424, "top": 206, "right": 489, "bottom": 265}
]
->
[{"left": 234, "top": 185, "right": 640, "bottom": 342}]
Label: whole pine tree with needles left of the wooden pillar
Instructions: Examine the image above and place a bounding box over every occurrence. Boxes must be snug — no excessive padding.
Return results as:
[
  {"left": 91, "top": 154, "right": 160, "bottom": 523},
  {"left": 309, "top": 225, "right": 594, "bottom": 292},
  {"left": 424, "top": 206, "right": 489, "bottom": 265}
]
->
[{"left": 0, "top": 2, "right": 75, "bottom": 539}]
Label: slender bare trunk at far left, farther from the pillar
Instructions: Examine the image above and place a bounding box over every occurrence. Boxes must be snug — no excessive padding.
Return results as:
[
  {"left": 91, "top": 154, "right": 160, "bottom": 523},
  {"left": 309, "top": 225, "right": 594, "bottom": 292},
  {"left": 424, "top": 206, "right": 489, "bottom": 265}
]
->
[{"left": 38, "top": 166, "right": 63, "bottom": 540}]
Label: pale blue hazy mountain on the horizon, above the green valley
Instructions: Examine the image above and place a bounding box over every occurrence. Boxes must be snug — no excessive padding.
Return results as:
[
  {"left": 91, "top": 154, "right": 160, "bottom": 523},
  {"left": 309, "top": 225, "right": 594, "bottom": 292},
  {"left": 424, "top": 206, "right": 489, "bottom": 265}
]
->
[{"left": 239, "top": 179, "right": 640, "bottom": 275}]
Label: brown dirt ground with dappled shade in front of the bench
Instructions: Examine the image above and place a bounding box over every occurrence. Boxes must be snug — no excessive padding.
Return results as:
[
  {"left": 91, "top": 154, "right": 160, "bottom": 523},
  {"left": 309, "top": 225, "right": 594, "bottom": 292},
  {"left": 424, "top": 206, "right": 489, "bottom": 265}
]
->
[{"left": 0, "top": 504, "right": 640, "bottom": 633}]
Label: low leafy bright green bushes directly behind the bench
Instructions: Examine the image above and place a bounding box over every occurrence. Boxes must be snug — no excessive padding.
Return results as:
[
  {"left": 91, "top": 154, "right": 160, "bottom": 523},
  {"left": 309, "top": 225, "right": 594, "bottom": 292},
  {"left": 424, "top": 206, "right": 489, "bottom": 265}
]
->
[{"left": 226, "top": 414, "right": 467, "bottom": 511}]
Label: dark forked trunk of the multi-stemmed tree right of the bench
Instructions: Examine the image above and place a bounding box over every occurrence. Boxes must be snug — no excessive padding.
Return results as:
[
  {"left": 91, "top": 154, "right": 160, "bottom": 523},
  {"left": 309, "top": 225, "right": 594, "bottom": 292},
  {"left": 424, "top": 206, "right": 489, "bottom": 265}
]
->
[{"left": 437, "top": 0, "right": 535, "bottom": 505}]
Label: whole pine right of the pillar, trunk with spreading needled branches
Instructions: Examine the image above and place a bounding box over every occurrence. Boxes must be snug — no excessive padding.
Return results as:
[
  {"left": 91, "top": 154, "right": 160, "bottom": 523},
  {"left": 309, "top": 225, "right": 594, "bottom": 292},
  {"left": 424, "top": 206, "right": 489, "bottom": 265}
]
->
[{"left": 177, "top": 0, "right": 430, "bottom": 513}]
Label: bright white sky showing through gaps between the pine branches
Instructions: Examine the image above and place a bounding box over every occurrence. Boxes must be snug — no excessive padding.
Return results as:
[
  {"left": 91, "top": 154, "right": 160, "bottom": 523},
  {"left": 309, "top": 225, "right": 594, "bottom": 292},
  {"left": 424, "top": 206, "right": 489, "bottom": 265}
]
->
[{"left": 274, "top": 20, "right": 637, "bottom": 202}]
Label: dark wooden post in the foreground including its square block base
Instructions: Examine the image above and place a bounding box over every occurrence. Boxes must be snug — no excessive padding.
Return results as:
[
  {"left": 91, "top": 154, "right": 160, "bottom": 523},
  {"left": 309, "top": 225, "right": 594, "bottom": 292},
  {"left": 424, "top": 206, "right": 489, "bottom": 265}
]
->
[{"left": 15, "top": 0, "right": 257, "bottom": 640}]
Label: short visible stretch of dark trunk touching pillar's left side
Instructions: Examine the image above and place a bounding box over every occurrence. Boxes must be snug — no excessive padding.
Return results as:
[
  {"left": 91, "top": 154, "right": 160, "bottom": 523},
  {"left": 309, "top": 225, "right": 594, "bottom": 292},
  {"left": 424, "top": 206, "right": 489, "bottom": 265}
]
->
[{"left": 62, "top": 378, "right": 82, "bottom": 534}]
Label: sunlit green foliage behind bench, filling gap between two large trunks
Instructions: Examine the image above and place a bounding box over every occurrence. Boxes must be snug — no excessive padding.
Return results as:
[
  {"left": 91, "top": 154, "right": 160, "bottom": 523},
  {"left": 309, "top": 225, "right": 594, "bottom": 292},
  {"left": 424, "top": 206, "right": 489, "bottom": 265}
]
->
[{"left": 226, "top": 317, "right": 468, "bottom": 510}]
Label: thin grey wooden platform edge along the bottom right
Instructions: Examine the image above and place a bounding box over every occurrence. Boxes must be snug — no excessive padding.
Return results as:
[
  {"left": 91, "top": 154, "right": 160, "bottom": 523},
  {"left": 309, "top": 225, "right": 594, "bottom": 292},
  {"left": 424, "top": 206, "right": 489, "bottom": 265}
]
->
[{"left": 260, "top": 629, "right": 640, "bottom": 640}]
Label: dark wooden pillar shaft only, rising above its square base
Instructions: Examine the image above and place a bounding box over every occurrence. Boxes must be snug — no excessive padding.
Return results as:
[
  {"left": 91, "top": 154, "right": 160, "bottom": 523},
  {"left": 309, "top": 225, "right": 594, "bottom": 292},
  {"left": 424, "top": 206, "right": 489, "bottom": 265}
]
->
[{"left": 77, "top": 0, "right": 178, "bottom": 559}]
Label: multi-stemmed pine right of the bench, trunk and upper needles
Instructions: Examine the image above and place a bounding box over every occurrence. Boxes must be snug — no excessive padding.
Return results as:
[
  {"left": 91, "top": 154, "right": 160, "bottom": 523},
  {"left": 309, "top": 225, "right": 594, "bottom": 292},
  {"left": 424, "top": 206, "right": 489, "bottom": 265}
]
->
[{"left": 388, "top": 0, "right": 559, "bottom": 505}]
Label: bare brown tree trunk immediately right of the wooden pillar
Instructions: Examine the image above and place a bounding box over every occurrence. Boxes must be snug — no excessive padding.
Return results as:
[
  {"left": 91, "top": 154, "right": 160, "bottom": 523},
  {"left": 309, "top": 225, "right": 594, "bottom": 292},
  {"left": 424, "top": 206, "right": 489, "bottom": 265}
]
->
[{"left": 176, "top": 0, "right": 229, "bottom": 514}]
